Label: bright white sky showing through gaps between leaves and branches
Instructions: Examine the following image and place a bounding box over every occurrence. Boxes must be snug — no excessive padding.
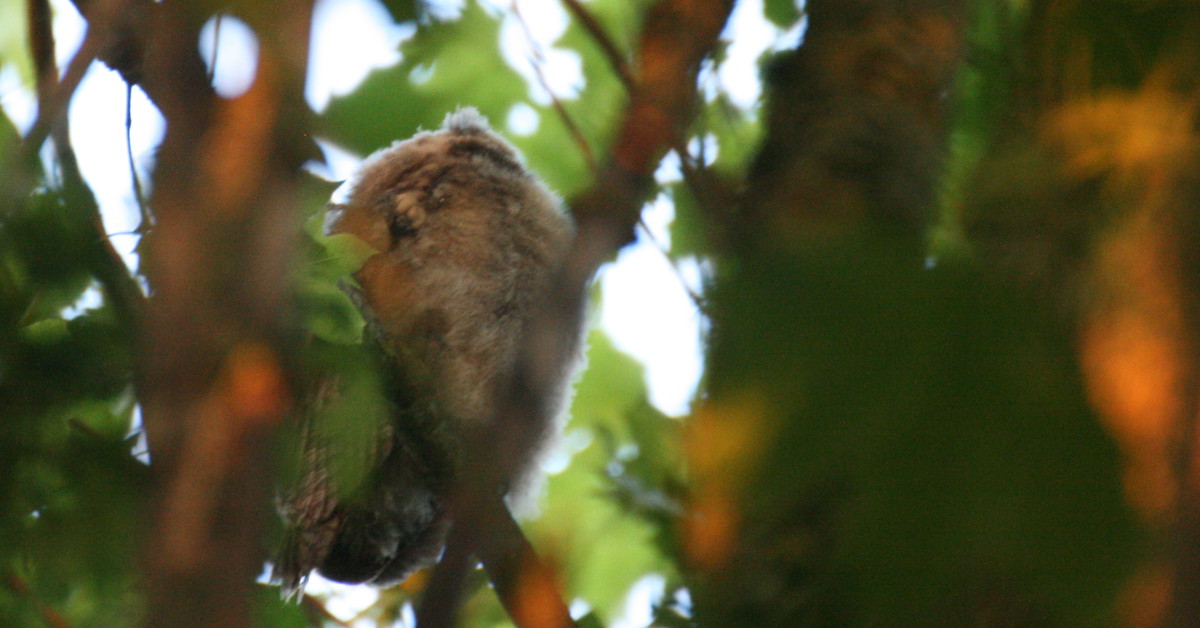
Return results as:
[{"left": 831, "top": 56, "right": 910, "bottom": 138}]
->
[{"left": 9, "top": 0, "right": 796, "bottom": 414}]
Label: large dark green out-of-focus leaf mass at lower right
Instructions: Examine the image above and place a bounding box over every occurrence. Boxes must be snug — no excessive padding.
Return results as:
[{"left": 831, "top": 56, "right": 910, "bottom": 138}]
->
[{"left": 690, "top": 238, "right": 1135, "bottom": 626}]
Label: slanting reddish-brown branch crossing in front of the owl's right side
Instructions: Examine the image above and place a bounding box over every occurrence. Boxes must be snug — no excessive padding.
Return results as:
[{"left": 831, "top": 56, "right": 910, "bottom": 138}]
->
[{"left": 421, "top": 0, "right": 733, "bottom": 628}]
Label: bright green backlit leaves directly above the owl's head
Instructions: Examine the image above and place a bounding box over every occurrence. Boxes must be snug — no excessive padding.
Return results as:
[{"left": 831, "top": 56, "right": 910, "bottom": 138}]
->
[{"left": 320, "top": 0, "right": 647, "bottom": 197}]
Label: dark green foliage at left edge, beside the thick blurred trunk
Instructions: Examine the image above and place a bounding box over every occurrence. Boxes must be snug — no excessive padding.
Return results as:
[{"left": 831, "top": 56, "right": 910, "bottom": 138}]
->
[{"left": 0, "top": 158, "right": 149, "bottom": 627}]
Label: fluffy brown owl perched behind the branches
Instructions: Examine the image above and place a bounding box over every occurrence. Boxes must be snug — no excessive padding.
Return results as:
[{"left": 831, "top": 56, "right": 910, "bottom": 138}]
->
[{"left": 275, "top": 109, "right": 575, "bottom": 592}]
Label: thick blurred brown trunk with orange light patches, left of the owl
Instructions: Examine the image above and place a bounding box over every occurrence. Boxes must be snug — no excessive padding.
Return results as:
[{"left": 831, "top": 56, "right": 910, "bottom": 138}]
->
[{"left": 50, "top": 0, "right": 324, "bottom": 626}]
